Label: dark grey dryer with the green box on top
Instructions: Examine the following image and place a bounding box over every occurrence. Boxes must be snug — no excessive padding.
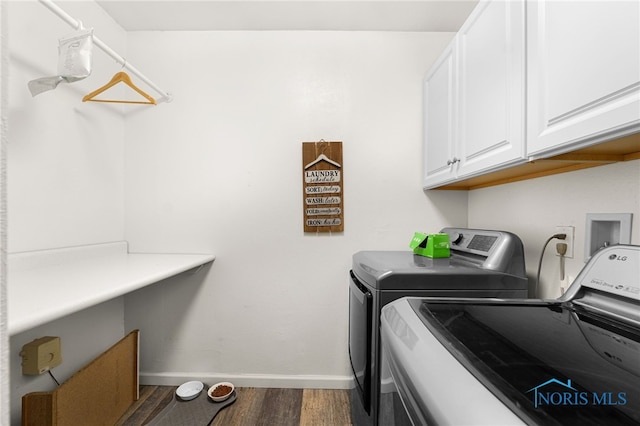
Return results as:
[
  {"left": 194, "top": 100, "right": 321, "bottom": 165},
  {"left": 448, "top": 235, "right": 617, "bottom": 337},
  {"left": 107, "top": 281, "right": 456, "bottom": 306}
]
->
[{"left": 349, "top": 228, "right": 528, "bottom": 426}]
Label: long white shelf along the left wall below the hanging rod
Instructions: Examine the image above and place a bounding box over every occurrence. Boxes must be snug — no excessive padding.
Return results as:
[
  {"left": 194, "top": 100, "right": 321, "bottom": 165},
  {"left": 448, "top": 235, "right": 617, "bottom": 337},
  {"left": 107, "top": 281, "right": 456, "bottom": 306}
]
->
[{"left": 7, "top": 241, "right": 215, "bottom": 336}]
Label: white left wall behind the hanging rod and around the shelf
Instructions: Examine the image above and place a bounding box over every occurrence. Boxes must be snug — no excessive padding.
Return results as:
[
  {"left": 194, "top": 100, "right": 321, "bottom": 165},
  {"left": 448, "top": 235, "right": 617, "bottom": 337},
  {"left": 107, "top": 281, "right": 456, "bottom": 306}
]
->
[{"left": 6, "top": 1, "right": 126, "bottom": 425}]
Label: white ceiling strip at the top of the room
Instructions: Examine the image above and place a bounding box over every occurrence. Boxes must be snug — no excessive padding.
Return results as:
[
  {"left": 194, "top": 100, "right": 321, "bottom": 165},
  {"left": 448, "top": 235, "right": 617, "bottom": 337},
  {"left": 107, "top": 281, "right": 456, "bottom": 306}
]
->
[{"left": 97, "top": 0, "right": 478, "bottom": 31}]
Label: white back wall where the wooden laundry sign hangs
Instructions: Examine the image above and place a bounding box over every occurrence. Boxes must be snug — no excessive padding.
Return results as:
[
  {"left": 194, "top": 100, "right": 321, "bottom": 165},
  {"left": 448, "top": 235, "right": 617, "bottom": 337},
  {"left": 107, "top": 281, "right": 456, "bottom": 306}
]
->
[{"left": 125, "top": 32, "right": 467, "bottom": 387}]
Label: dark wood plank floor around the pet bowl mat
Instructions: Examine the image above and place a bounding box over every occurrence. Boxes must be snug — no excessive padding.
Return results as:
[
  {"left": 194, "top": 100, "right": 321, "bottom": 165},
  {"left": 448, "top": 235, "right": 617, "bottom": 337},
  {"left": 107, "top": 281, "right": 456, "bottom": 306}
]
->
[{"left": 117, "top": 386, "right": 351, "bottom": 426}]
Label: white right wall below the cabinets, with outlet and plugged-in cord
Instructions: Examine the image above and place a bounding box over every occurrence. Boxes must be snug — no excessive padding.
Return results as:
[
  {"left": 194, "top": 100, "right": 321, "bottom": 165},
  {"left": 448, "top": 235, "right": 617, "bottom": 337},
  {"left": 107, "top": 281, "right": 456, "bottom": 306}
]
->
[{"left": 469, "top": 160, "right": 640, "bottom": 298}]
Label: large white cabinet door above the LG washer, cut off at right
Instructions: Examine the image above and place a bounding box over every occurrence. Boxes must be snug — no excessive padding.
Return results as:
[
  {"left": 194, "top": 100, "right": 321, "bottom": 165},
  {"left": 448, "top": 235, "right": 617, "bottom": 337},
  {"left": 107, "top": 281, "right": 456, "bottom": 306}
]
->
[{"left": 527, "top": 0, "right": 640, "bottom": 158}]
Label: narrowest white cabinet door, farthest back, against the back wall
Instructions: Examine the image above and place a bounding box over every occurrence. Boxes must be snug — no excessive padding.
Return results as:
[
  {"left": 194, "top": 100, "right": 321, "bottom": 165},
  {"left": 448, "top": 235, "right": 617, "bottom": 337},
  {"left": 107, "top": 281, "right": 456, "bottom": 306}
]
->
[{"left": 423, "top": 39, "right": 456, "bottom": 189}]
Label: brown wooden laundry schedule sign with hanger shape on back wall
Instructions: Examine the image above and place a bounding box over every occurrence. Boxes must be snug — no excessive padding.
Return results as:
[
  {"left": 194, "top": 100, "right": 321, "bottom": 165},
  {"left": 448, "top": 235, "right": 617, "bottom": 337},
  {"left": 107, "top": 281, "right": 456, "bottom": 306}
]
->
[{"left": 302, "top": 140, "right": 344, "bottom": 232}]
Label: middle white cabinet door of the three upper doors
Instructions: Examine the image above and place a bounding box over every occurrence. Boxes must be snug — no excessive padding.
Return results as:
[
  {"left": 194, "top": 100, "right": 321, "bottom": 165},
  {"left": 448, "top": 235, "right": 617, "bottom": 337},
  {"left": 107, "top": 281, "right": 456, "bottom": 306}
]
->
[{"left": 457, "top": 0, "right": 526, "bottom": 177}]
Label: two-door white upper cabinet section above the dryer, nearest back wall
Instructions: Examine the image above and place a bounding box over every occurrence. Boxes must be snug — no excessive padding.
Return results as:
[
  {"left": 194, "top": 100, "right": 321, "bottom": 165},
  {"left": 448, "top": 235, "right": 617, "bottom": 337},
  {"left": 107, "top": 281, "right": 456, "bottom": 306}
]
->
[{"left": 423, "top": 0, "right": 525, "bottom": 188}]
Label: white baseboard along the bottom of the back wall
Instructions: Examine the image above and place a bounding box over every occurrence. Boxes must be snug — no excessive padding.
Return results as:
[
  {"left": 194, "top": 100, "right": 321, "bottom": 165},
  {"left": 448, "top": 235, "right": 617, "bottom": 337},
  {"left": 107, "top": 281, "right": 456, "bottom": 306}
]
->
[{"left": 140, "top": 371, "right": 354, "bottom": 389}]
